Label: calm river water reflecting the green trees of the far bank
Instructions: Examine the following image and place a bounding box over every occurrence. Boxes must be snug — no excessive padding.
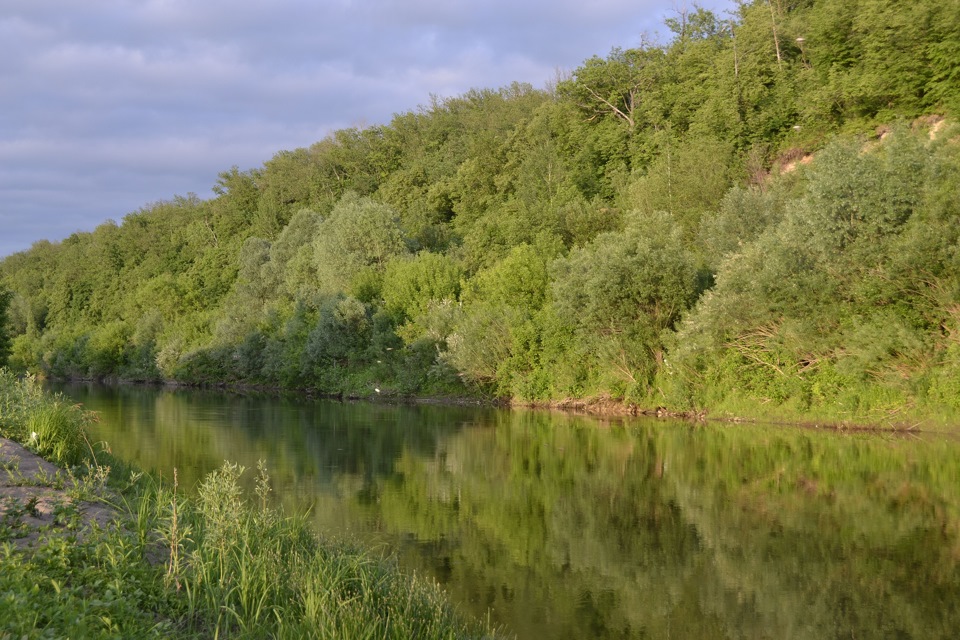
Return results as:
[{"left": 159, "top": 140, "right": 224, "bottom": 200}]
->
[{"left": 50, "top": 384, "right": 960, "bottom": 640}]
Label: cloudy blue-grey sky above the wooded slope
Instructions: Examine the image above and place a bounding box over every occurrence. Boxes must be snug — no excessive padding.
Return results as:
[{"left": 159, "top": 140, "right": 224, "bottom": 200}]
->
[{"left": 0, "top": 0, "right": 734, "bottom": 258}]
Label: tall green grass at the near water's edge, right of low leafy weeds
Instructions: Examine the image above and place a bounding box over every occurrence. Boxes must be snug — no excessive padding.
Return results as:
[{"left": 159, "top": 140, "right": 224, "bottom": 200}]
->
[{"left": 147, "top": 463, "right": 502, "bottom": 640}]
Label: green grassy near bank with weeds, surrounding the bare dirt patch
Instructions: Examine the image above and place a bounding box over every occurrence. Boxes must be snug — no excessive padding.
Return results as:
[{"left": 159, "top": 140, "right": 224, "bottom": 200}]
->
[{"left": 0, "top": 370, "right": 494, "bottom": 638}]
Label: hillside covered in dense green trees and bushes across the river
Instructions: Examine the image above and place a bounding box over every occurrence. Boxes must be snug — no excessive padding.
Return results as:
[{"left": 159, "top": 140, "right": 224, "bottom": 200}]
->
[{"left": 0, "top": 0, "right": 960, "bottom": 422}]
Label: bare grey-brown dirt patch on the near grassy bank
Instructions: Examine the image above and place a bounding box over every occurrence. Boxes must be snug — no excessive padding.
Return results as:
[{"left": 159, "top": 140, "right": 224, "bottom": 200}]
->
[{"left": 0, "top": 438, "right": 117, "bottom": 549}]
